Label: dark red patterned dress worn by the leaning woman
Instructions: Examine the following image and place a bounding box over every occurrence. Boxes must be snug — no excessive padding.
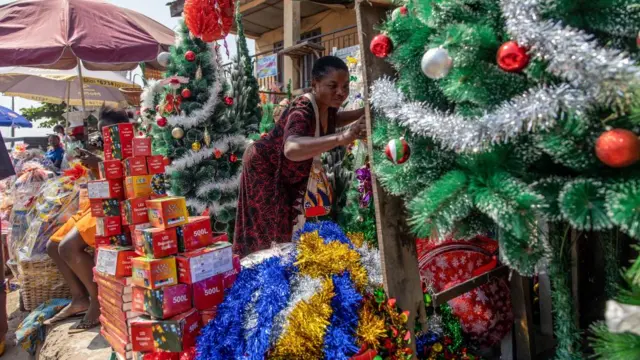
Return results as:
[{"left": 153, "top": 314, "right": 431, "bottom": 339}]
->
[{"left": 233, "top": 96, "right": 337, "bottom": 256}]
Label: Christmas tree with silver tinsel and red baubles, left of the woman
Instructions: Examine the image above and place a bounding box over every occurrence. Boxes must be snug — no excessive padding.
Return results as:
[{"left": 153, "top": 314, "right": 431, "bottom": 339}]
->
[{"left": 143, "top": 24, "right": 248, "bottom": 232}]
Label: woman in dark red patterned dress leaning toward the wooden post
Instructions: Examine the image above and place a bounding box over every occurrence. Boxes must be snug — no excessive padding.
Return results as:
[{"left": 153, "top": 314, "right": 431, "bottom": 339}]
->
[{"left": 233, "top": 56, "right": 366, "bottom": 256}]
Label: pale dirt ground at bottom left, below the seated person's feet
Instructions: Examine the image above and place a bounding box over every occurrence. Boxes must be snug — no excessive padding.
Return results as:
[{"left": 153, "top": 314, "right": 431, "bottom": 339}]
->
[{"left": 2, "top": 291, "right": 111, "bottom": 360}]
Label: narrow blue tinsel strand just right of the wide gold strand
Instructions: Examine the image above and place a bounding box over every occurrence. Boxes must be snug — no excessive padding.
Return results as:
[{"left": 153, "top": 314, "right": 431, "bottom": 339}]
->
[{"left": 323, "top": 271, "right": 362, "bottom": 360}]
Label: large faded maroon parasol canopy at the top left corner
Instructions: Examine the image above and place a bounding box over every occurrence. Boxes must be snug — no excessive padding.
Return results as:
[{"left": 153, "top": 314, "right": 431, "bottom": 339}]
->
[{"left": 0, "top": 0, "right": 174, "bottom": 70}]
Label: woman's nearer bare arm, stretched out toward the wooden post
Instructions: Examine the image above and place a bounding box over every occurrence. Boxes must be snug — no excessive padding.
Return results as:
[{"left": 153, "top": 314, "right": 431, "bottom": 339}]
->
[{"left": 284, "top": 118, "right": 366, "bottom": 161}]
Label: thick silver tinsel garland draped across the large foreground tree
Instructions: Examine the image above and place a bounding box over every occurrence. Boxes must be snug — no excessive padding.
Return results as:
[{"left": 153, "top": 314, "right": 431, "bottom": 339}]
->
[{"left": 371, "top": 0, "right": 640, "bottom": 152}]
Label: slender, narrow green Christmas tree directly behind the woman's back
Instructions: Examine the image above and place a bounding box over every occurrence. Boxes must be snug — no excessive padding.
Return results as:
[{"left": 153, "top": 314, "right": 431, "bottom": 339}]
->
[{"left": 229, "top": 1, "right": 261, "bottom": 136}]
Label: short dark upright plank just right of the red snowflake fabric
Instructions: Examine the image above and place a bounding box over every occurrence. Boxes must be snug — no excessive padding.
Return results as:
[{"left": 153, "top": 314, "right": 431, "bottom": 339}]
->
[{"left": 511, "top": 271, "right": 535, "bottom": 360}]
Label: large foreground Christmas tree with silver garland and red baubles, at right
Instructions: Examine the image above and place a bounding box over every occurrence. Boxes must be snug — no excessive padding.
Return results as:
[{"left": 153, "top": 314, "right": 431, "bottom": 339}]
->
[{"left": 364, "top": 0, "right": 640, "bottom": 359}]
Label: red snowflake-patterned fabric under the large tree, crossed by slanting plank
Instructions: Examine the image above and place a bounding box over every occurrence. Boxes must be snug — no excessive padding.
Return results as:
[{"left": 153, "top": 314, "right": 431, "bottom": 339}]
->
[{"left": 417, "top": 236, "right": 513, "bottom": 345}]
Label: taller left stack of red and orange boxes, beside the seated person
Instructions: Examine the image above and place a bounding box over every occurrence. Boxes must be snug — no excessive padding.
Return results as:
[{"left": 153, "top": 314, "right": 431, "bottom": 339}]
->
[{"left": 88, "top": 124, "right": 166, "bottom": 359}]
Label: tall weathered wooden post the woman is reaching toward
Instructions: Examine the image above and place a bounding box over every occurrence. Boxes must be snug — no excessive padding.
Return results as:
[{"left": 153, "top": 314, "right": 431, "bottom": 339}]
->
[{"left": 356, "top": 0, "right": 426, "bottom": 350}]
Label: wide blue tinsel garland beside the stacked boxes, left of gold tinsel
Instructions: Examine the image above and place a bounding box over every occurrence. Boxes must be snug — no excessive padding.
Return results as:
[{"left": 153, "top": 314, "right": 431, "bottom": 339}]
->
[{"left": 196, "top": 257, "right": 291, "bottom": 360}]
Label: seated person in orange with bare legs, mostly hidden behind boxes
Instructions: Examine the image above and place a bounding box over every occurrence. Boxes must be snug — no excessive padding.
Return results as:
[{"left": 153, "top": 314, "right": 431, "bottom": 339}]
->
[{"left": 45, "top": 107, "right": 129, "bottom": 334}]
